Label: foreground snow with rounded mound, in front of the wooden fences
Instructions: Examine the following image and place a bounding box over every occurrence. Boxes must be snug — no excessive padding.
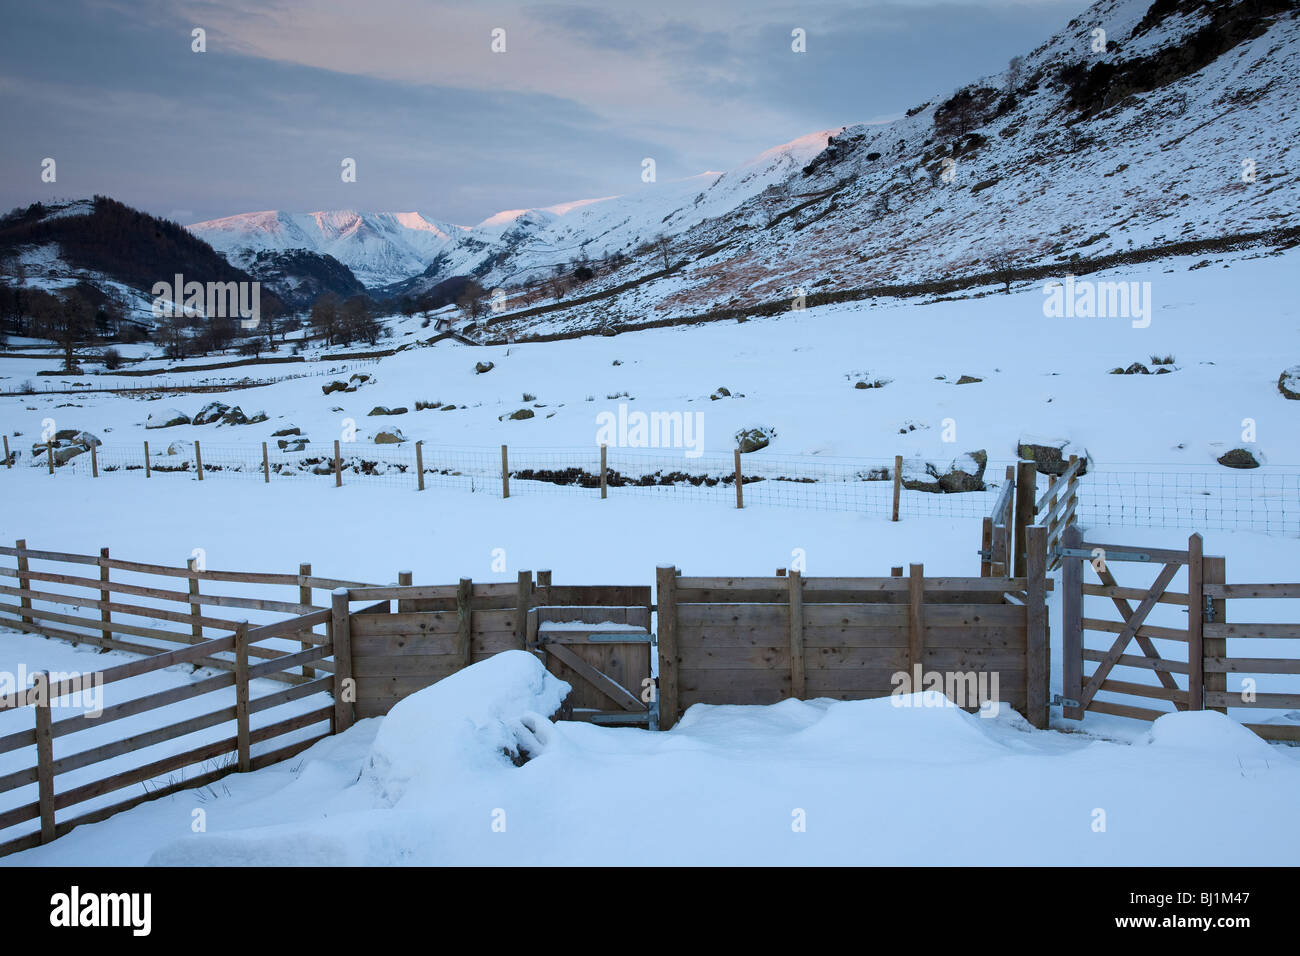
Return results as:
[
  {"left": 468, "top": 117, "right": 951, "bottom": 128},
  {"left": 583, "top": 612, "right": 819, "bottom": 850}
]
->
[{"left": 4, "top": 652, "right": 1300, "bottom": 866}]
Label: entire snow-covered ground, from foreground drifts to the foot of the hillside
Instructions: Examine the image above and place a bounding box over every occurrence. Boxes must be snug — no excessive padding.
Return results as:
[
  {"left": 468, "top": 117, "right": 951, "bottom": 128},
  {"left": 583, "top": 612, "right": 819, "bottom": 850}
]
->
[{"left": 0, "top": 243, "right": 1300, "bottom": 864}]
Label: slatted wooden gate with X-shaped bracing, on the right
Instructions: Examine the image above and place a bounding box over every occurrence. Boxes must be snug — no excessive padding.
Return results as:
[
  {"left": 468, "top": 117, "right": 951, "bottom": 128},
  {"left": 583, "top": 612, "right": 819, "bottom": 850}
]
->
[{"left": 1056, "top": 525, "right": 1206, "bottom": 721}]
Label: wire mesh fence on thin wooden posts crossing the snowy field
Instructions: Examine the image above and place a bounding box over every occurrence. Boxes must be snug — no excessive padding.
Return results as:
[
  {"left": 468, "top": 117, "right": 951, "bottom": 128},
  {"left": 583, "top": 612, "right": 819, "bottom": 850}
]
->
[{"left": 12, "top": 436, "right": 1300, "bottom": 536}]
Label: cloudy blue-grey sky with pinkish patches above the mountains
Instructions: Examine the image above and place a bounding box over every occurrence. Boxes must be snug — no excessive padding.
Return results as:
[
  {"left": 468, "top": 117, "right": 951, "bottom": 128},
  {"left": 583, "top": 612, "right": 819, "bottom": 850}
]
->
[{"left": 0, "top": 0, "right": 1087, "bottom": 224}]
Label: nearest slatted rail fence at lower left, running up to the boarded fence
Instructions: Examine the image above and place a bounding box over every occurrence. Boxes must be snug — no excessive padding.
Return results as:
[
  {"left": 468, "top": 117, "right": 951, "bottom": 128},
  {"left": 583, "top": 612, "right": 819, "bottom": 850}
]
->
[{"left": 0, "top": 611, "right": 335, "bottom": 856}]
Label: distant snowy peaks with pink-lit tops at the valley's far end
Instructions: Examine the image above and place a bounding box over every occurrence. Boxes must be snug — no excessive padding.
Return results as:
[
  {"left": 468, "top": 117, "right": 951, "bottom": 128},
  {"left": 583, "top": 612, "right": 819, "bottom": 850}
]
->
[{"left": 189, "top": 209, "right": 464, "bottom": 286}]
